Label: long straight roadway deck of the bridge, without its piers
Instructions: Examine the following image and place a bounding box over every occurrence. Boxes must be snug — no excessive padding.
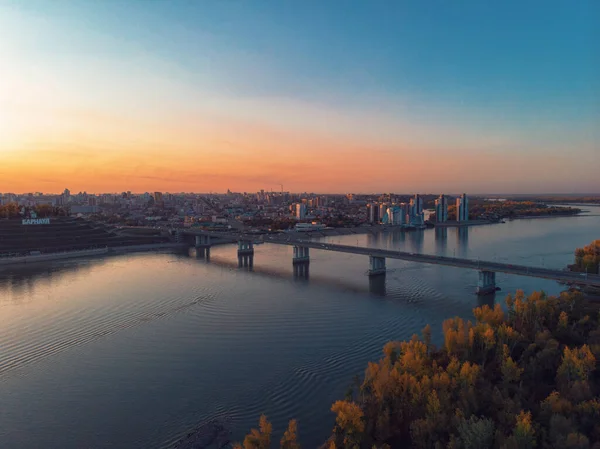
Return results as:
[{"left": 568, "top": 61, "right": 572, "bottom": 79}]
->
[{"left": 183, "top": 232, "right": 600, "bottom": 287}]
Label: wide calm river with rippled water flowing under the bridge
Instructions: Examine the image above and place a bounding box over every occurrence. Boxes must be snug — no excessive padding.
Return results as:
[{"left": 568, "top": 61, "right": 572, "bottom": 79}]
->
[{"left": 0, "top": 206, "right": 600, "bottom": 449}]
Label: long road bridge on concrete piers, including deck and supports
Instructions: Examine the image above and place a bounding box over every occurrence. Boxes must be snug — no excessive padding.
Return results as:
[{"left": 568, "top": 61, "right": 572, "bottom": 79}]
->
[{"left": 183, "top": 230, "right": 600, "bottom": 295}]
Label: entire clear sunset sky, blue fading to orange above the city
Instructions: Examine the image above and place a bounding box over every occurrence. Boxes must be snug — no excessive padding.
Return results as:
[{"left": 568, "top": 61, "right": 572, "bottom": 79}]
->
[{"left": 0, "top": 0, "right": 600, "bottom": 193}]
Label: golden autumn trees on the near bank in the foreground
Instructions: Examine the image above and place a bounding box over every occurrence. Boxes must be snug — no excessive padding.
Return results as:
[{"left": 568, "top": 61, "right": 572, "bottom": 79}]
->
[{"left": 236, "top": 291, "right": 600, "bottom": 449}]
